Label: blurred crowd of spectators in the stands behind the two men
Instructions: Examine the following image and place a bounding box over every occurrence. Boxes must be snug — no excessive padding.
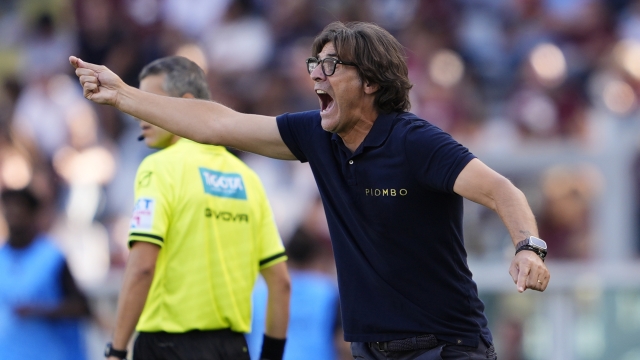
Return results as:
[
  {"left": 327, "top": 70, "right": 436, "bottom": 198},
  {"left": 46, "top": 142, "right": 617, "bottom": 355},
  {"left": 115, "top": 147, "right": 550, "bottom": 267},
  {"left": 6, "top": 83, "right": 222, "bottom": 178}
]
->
[{"left": 0, "top": 0, "right": 640, "bottom": 358}]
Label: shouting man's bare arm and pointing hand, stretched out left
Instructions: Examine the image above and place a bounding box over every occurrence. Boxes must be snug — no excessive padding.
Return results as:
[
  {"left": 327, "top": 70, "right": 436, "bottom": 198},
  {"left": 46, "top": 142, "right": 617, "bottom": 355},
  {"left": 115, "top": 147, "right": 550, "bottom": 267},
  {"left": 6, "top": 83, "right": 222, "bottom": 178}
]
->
[{"left": 69, "top": 56, "right": 295, "bottom": 160}]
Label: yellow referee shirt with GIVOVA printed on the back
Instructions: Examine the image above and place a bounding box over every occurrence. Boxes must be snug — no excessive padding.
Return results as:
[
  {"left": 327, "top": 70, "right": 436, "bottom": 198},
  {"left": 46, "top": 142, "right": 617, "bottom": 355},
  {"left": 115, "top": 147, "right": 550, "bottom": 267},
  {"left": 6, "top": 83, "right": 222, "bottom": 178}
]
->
[{"left": 129, "top": 139, "right": 286, "bottom": 333}]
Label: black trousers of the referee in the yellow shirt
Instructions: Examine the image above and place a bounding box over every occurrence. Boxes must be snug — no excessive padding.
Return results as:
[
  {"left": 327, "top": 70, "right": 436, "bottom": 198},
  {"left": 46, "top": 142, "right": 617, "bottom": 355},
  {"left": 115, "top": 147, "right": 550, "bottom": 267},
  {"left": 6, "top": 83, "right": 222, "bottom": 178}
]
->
[{"left": 133, "top": 330, "right": 250, "bottom": 360}]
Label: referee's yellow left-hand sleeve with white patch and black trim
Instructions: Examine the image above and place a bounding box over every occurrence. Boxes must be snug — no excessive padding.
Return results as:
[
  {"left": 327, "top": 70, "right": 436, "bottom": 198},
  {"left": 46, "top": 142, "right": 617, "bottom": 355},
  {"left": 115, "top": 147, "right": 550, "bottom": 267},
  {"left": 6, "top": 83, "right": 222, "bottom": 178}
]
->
[{"left": 129, "top": 157, "right": 171, "bottom": 247}]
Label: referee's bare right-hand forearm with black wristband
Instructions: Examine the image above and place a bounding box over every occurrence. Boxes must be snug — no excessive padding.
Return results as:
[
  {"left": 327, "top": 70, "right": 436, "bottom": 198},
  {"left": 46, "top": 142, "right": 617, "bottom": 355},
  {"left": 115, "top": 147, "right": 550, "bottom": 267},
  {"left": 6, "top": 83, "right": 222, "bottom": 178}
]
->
[{"left": 260, "top": 261, "right": 291, "bottom": 359}]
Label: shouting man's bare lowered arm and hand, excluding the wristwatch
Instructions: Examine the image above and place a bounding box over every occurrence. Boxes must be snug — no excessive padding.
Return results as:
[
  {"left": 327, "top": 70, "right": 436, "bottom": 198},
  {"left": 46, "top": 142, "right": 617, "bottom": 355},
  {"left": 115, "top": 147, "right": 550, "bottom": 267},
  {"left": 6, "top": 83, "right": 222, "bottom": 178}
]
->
[{"left": 453, "top": 159, "right": 550, "bottom": 292}]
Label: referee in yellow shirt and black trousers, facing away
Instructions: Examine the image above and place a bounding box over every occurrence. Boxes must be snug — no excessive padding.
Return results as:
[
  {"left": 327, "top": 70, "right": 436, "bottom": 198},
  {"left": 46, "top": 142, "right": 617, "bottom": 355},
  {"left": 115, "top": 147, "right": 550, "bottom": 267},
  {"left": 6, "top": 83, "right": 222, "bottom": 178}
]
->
[{"left": 105, "top": 56, "right": 290, "bottom": 360}]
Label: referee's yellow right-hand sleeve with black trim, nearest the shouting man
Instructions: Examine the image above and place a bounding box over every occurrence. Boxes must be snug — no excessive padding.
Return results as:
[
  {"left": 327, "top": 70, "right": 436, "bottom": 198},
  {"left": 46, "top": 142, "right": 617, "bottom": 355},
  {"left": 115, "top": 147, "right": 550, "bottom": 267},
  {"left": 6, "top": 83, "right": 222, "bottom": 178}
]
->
[{"left": 252, "top": 179, "right": 287, "bottom": 269}]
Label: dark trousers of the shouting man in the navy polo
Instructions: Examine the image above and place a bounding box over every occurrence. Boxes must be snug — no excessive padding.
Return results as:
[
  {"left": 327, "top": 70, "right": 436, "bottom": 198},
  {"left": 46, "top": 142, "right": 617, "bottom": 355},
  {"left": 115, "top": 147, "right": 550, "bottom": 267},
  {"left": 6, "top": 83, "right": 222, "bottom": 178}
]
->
[{"left": 351, "top": 339, "right": 497, "bottom": 360}]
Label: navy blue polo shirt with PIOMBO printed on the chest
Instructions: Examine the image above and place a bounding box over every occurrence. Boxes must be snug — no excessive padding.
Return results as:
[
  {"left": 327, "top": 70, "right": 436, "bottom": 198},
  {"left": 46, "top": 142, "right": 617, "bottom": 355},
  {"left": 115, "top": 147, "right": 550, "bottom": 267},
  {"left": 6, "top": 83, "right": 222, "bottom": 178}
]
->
[{"left": 277, "top": 111, "right": 491, "bottom": 347}]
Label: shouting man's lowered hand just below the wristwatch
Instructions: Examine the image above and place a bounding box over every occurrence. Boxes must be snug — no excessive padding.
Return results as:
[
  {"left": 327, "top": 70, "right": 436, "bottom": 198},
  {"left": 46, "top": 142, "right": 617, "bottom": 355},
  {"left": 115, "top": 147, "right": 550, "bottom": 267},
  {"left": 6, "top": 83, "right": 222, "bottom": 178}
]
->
[{"left": 509, "top": 250, "right": 551, "bottom": 292}]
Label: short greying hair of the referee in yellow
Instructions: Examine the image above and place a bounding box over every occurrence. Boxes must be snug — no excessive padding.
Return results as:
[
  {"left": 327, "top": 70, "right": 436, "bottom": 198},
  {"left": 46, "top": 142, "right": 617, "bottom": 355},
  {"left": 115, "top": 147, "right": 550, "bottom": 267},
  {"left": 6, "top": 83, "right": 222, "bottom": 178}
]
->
[{"left": 138, "top": 56, "right": 211, "bottom": 100}]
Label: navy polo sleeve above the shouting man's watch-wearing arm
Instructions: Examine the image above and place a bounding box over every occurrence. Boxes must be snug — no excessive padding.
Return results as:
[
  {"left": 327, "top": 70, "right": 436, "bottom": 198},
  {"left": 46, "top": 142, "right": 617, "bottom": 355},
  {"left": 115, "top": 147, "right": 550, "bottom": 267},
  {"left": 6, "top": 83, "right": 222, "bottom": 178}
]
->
[{"left": 405, "top": 121, "right": 475, "bottom": 193}]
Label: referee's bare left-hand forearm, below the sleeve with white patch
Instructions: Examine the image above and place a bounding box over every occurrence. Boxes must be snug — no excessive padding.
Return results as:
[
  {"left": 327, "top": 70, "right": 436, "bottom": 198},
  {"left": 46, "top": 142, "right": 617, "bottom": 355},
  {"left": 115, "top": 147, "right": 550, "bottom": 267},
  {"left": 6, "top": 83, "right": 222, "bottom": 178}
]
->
[{"left": 113, "top": 241, "right": 160, "bottom": 356}]
